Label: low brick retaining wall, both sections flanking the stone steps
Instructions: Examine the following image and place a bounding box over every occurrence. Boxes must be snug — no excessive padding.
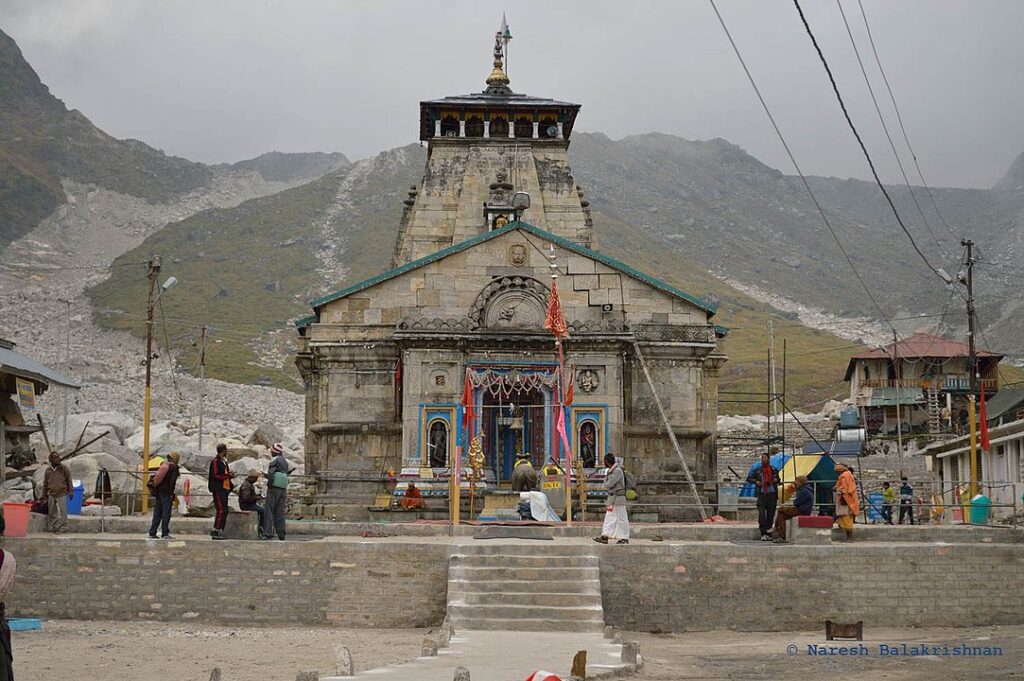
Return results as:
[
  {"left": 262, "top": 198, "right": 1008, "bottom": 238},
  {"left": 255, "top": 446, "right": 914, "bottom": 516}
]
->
[{"left": 6, "top": 536, "right": 1024, "bottom": 632}]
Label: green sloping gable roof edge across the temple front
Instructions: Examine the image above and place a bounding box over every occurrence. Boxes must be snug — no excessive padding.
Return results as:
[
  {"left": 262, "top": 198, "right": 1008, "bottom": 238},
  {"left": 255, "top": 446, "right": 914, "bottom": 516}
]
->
[{"left": 303, "top": 220, "right": 724, "bottom": 319}]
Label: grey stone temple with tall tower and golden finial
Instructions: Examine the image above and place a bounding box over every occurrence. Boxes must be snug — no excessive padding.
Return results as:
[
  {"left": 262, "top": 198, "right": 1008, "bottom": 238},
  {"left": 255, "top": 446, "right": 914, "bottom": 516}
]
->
[{"left": 296, "top": 34, "right": 725, "bottom": 517}]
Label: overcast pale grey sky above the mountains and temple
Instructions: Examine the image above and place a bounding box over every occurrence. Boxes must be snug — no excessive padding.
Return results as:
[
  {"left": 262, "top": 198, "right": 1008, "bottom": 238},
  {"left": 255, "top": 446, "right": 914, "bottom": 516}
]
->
[{"left": 0, "top": 0, "right": 1024, "bottom": 186}]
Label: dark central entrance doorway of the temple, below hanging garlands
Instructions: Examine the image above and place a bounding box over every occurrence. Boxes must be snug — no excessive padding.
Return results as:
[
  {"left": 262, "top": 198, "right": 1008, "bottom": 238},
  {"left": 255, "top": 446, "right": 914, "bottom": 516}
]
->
[{"left": 481, "top": 388, "right": 549, "bottom": 483}]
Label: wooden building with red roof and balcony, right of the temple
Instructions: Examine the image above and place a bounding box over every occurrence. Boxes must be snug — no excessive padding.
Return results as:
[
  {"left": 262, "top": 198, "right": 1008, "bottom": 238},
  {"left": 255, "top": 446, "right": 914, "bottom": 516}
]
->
[{"left": 844, "top": 334, "right": 1002, "bottom": 434}]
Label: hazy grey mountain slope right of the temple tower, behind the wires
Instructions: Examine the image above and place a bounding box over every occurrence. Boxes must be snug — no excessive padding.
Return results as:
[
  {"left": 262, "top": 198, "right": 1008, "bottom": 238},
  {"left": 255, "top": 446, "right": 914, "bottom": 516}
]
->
[{"left": 570, "top": 133, "right": 1024, "bottom": 354}]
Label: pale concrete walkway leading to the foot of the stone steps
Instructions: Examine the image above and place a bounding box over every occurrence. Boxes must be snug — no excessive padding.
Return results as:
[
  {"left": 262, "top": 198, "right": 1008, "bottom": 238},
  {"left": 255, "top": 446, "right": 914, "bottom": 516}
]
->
[{"left": 319, "top": 631, "right": 635, "bottom": 681}]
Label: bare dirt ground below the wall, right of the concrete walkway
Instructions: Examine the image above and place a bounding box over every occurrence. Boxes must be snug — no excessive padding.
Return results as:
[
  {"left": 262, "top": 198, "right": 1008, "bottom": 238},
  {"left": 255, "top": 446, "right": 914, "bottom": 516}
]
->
[{"left": 624, "top": 626, "right": 1024, "bottom": 681}]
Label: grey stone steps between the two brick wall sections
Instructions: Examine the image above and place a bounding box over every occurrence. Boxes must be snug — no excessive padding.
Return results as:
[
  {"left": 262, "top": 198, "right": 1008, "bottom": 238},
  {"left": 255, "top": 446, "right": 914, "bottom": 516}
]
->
[{"left": 447, "top": 543, "right": 604, "bottom": 633}]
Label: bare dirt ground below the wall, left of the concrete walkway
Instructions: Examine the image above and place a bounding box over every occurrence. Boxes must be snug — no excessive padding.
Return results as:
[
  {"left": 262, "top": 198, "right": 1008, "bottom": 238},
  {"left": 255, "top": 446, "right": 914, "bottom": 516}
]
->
[{"left": 12, "top": 620, "right": 426, "bottom": 681}]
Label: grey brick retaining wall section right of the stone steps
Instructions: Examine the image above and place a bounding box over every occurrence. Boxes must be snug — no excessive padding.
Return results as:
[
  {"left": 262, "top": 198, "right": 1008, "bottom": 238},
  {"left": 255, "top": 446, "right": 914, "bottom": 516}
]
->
[{"left": 599, "top": 544, "right": 1024, "bottom": 632}]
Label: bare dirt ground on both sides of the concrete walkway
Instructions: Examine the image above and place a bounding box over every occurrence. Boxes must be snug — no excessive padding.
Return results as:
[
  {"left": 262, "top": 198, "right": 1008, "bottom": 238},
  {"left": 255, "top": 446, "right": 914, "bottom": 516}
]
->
[{"left": 13, "top": 621, "right": 1024, "bottom": 681}]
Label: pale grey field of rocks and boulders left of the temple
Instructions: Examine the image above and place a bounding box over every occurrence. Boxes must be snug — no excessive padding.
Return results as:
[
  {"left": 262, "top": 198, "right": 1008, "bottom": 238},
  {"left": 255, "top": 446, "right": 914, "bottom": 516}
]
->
[{"left": 0, "top": 167, "right": 303, "bottom": 507}]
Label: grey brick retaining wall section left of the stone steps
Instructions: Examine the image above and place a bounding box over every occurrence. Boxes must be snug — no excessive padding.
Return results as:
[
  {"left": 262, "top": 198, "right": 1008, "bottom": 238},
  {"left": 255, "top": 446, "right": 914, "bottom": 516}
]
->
[{"left": 6, "top": 536, "right": 449, "bottom": 628}]
